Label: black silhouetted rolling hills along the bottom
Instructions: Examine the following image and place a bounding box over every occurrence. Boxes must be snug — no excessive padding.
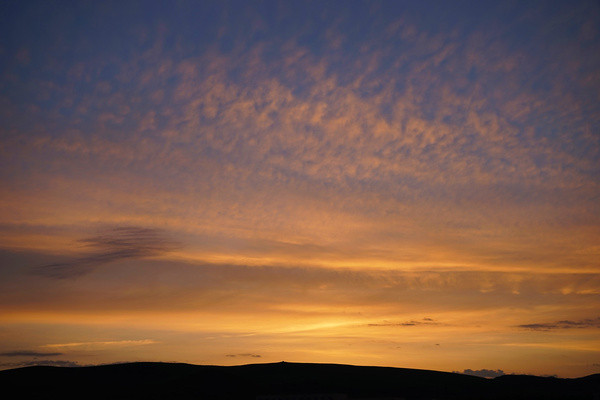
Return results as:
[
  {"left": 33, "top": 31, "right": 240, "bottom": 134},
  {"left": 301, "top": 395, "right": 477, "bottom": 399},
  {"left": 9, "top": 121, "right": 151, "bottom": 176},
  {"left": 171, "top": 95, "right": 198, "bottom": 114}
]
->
[{"left": 0, "top": 363, "right": 600, "bottom": 400}]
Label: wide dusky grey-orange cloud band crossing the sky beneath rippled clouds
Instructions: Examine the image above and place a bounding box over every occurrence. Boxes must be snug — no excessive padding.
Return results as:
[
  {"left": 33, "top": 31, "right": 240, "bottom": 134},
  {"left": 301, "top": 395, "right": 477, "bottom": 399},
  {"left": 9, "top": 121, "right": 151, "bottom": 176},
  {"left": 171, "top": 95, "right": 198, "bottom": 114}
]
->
[{"left": 5, "top": 255, "right": 600, "bottom": 318}]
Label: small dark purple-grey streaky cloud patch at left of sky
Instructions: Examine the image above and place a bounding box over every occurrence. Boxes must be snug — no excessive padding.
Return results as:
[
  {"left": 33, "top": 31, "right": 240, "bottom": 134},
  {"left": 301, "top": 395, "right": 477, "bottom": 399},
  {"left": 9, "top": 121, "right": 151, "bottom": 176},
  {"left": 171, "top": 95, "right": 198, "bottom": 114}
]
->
[{"left": 35, "top": 226, "right": 176, "bottom": 279}]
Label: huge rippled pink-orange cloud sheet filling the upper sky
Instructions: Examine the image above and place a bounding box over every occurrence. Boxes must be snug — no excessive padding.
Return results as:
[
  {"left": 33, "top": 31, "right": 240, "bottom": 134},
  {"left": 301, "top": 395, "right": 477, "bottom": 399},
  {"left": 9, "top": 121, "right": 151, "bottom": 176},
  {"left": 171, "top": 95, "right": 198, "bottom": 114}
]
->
[{"left": 5, "top": 3, "right": 595, "bottom": 276}]
